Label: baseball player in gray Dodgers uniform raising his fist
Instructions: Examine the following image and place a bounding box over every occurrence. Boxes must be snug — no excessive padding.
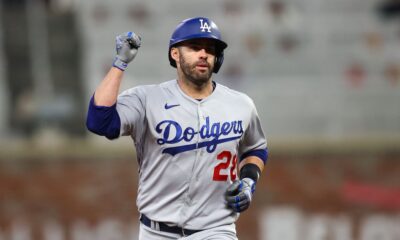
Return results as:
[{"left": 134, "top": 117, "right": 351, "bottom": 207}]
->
[{"left": 86, "top": 17, "right": 267, "bottom": 240}]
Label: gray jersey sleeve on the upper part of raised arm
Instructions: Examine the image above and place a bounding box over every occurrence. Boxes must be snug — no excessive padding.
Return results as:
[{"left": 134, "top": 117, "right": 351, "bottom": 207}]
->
[{"left": 117, "top": 87, "right": 146, "bottom": 136}]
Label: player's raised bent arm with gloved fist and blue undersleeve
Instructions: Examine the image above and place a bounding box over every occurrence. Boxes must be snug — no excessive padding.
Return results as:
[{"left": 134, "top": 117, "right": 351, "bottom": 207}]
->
[{"left": 86, "top": 32, "right": 141, "bottom": 139}]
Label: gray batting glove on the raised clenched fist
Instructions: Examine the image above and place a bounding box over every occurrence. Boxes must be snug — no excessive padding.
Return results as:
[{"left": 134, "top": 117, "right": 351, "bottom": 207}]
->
[{"left": 113, "top": 32, "right": 141, "bottom": 71}]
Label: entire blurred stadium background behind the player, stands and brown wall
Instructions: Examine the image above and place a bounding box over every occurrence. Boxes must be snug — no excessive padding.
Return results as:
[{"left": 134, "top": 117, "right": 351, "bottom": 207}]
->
[{"left": 0, "top": 0, "right": 400, "bottom": 240}]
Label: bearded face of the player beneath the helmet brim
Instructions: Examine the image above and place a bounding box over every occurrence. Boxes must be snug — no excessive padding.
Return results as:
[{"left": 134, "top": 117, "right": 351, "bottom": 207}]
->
[{"left": 173, "top": 39, "right": 216, "bottom": 86}]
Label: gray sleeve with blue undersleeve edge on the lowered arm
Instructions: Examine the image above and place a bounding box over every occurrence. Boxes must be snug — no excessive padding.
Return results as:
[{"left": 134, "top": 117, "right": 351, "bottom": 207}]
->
[{"left": 239, "top": 101, "right": 268, "bottom": 163}]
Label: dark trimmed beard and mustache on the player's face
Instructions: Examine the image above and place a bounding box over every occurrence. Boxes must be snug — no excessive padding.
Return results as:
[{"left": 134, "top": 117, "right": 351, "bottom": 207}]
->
[{"left": 179, "top": 49, "right": 214, "bottom": 86}]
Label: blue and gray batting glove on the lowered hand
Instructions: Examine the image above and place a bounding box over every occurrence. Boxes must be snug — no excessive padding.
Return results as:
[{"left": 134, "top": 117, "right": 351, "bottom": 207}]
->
[{"left": 225, "top": 178, "right": 256, "bottom": 212}]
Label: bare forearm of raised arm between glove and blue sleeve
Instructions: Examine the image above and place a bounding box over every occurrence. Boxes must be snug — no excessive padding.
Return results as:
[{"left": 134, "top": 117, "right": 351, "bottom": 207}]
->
[{"left": 94, "top": 67, "right": 124, "bottom": 107}]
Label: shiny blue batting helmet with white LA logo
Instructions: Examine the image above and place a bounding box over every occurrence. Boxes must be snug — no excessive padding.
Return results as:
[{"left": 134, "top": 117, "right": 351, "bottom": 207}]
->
[{"left": 168, "top": 17, "right": 228, "bottom": 73}]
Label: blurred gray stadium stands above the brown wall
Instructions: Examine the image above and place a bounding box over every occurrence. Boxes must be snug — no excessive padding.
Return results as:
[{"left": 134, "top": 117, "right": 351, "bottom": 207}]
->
[{"left": 0, "top": 0, "right": 400, "bottom": 142}]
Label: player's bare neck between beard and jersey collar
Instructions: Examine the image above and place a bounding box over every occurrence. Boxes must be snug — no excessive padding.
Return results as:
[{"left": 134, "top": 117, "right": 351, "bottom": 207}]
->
[{"left": 178, "top": 77, "right": 213, "bottom": 99}]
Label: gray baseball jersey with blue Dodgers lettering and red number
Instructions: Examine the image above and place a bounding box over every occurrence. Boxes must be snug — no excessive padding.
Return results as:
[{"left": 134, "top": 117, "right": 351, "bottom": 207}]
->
[{"left": 117, "top": 80, "right": 267, "bottom": 229}]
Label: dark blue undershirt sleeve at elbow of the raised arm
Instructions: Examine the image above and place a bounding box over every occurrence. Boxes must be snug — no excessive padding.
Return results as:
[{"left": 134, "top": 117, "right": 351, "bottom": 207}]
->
[{"left": 86, "top": 96, "right": 121, "bottom": 139}]
